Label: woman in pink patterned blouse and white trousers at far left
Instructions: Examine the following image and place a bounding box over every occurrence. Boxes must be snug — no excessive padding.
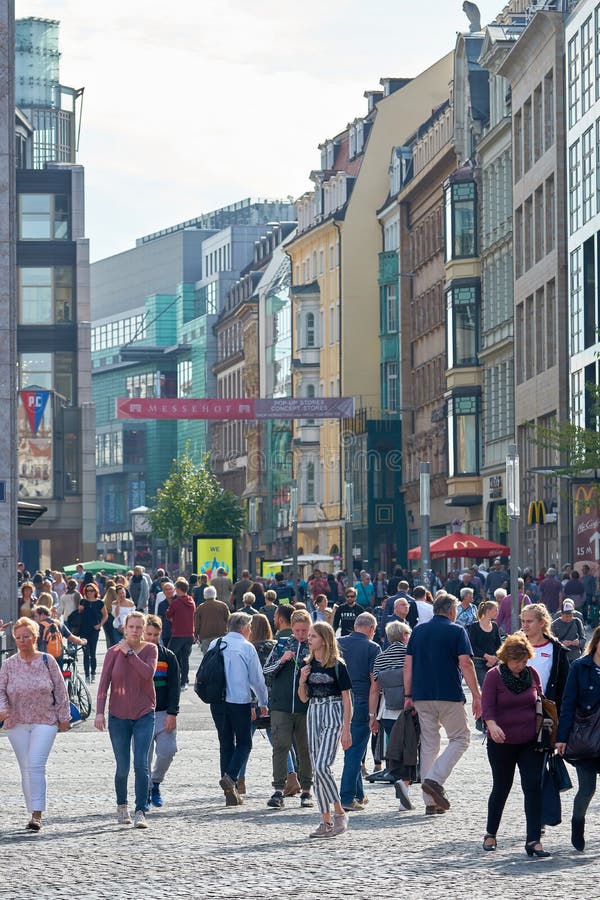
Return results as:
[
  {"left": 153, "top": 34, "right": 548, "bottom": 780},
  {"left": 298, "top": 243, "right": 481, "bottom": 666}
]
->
[{"left": 0, "top": 616, "right": 71, "bottom": 832}]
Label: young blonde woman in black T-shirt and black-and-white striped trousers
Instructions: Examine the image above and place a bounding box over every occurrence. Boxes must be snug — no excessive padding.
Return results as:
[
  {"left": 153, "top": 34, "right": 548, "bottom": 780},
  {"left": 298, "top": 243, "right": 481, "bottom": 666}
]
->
[{"left": 298, "top": 622, "right": 352, "bottom": 838}]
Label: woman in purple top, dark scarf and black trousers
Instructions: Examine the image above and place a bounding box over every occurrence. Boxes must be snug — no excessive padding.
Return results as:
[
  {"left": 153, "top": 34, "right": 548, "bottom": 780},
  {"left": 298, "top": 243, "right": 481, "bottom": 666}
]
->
[{"left": 481, "top": 632, "right": 550, "bottom": 857}]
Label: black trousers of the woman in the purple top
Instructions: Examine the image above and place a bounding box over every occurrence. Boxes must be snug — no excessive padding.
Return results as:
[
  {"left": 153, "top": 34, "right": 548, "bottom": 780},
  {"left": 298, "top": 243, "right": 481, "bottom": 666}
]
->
[{"left": 487, "top": 738, "right": 544, "bottom": 843}]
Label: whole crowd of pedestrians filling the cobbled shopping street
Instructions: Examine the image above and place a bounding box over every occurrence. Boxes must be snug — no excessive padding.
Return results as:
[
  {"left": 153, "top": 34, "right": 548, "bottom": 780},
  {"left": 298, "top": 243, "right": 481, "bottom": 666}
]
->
[{"left": 0, "top": 560, "right": 600, "bottom": 857}]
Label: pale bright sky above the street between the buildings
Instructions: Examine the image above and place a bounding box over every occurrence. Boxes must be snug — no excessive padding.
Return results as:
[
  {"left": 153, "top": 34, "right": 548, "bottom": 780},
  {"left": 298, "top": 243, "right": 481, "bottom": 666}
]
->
[{"left": 16, "top": 0, "right": 503, "bottom": 260}]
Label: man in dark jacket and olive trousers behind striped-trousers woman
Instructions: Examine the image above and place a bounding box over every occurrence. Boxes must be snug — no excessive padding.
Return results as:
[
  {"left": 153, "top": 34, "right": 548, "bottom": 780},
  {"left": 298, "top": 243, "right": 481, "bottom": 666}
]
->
[{"left": 263, "top": 604, "right": 313, "bottom": 809}]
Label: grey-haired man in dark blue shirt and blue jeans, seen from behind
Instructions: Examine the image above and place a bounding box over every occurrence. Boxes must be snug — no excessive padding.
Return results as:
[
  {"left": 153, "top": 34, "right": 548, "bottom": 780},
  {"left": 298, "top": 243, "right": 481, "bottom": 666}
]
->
[{"left": 338, "top": 612, "right": 381, "bottom": 811}]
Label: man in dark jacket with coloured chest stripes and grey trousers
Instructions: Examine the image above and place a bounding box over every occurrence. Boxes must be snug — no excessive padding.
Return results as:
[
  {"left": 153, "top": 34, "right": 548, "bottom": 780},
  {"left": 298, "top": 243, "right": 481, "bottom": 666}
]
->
[{"left": 144, "top": 615, "right": 180, "bottom": 809}]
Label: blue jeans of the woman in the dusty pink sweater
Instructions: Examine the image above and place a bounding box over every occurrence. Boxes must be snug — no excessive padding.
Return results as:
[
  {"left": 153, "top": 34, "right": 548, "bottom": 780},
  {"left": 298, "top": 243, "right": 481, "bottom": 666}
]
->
[{"left": 108, "top": 712, "right": 154, "bottom": 812}]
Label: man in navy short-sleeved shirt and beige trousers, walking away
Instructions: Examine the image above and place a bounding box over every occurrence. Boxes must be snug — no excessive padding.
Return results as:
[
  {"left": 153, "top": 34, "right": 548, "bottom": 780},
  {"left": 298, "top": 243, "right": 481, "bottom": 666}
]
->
[{"left": 404, "top": 594, "right": 481, "bottom": 815}]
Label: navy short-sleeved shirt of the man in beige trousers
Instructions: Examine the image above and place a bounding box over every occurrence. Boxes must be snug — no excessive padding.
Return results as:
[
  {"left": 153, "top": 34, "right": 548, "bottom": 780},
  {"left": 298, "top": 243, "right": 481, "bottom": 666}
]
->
[{"left": 406, "top": 616, "right": 473, "bottom": 703}]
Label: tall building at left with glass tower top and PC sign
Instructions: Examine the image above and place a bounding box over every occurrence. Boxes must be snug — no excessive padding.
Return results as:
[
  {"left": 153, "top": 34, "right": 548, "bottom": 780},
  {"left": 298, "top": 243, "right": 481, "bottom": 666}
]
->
[{"left": 16, "top": 19, "right": 95, "bottom": 571}]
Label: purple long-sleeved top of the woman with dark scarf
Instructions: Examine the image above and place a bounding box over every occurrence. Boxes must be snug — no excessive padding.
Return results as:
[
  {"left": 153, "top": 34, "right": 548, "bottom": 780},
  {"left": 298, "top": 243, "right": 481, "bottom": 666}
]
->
[{"left": 481, "top": 666, "right": 541, "bottom": 744}]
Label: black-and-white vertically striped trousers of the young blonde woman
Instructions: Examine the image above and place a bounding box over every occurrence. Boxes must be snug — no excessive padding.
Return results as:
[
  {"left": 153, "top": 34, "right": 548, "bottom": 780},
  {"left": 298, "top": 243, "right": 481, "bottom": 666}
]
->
[{"left": 306, "top": 697, "right": 344, "bottom": 813}]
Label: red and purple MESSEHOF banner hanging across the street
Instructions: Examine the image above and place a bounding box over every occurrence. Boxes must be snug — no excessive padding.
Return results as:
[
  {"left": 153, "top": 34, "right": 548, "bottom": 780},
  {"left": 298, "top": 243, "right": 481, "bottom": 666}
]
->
[{"left": 115, "top": 392, "right": 354, "bottom": 421}]
